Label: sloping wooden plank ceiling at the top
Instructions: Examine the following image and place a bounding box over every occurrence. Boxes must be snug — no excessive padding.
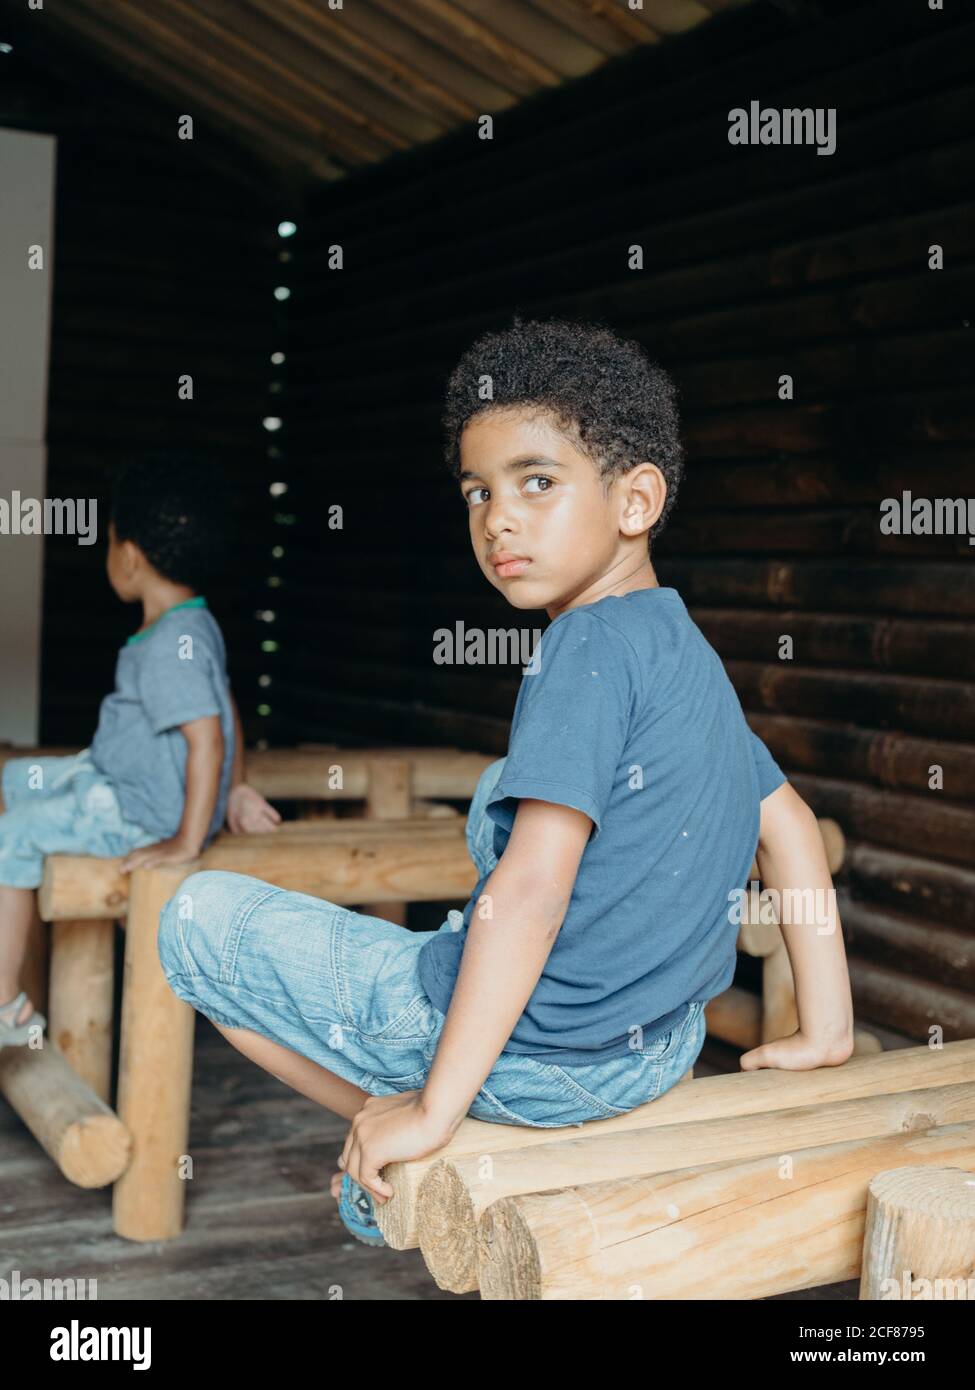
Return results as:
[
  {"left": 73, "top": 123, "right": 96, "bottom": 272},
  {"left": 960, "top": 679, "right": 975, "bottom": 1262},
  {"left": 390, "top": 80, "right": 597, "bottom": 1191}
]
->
[{"left": 34, "top": 0, "right": 747, "bottom": 183}]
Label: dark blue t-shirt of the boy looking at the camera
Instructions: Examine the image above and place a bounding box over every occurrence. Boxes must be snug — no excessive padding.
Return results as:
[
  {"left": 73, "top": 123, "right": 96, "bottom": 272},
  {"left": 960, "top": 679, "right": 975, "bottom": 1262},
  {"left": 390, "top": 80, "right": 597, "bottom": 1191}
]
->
[{"left": 419, "top": 588, "right": 786, "bottom": 1065}]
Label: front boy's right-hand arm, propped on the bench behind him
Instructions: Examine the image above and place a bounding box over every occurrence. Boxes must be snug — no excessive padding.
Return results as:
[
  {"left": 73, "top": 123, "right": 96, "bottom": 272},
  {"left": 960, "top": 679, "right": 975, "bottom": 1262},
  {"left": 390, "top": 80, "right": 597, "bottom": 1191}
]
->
[{"left": 740, "top": 781, "right": 853, "bottom": 1070}]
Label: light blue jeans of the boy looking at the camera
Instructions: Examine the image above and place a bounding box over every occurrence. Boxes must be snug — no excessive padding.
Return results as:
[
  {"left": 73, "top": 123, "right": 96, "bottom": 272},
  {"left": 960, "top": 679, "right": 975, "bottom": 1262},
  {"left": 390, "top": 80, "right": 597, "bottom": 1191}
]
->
[{"left": 159, "top": 763, "right": 705, "bottom": 1129}]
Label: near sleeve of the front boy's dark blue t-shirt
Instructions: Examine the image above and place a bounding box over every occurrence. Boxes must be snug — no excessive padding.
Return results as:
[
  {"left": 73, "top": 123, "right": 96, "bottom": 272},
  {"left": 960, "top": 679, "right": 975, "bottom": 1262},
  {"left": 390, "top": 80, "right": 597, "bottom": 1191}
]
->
[{"left": 485, "top": 609, "right": 640, "bottom": 837}]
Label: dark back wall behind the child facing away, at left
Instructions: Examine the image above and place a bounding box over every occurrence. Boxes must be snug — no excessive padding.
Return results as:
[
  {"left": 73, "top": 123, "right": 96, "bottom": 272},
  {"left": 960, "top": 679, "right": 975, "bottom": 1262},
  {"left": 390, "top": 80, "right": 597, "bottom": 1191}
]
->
[{"left": 0, "top": 6, "right": 291, "bottom": 744}]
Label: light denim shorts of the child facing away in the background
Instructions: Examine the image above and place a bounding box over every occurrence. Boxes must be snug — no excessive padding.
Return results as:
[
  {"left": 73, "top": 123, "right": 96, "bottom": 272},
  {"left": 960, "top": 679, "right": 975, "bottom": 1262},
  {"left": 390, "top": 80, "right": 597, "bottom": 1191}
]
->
[{"left": 0, "top": 748, "right": 159, "bottom": 888}]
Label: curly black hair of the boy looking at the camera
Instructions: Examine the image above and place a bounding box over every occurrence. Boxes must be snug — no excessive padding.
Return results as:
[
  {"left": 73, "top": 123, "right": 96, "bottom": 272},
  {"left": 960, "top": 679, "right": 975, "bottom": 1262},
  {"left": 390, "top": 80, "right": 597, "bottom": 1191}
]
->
[{"left": 441, "top": 314, "right": 684, "bottom": 541}]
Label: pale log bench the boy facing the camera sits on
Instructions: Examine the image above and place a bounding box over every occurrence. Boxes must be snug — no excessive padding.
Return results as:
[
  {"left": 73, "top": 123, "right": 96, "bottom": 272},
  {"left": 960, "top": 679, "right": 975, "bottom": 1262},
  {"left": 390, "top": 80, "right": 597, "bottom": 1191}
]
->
[{"left": 376, "top": 1040, "right": 975, "bottom": 1300}]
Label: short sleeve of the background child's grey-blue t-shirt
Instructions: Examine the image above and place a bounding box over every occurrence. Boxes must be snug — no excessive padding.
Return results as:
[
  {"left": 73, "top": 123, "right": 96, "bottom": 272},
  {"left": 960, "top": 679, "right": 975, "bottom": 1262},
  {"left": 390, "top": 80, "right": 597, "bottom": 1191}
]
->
[{"left": 139, "top": 621, "right": 221, "bottom": 734}]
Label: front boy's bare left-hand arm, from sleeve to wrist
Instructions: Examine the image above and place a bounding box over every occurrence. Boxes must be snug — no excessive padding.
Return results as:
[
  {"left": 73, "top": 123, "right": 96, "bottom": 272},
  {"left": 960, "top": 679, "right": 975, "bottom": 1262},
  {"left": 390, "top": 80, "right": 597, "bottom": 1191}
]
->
[{"left": 420, "top": 799, "right": 593, "bottom": 1137}]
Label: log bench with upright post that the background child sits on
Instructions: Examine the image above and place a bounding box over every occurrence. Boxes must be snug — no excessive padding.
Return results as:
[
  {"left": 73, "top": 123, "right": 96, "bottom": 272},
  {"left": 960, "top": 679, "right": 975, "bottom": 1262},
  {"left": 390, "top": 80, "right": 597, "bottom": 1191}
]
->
[{"left": 15, "top": 817, "right": 845, "bottom": 1240}]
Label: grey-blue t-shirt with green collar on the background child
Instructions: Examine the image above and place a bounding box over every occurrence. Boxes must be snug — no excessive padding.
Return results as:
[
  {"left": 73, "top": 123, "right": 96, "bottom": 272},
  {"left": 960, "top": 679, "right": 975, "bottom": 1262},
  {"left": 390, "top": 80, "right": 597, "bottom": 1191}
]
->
[{"left": 90, "top": 596, "right": 235, "bottom": 842}]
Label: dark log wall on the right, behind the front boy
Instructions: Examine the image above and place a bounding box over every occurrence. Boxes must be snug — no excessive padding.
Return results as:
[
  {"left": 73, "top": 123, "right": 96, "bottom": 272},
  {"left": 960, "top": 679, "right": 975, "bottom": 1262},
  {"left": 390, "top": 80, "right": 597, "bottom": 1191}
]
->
[{"left": 278, "top": 0, "right": 975, "bottom": 1038}]
